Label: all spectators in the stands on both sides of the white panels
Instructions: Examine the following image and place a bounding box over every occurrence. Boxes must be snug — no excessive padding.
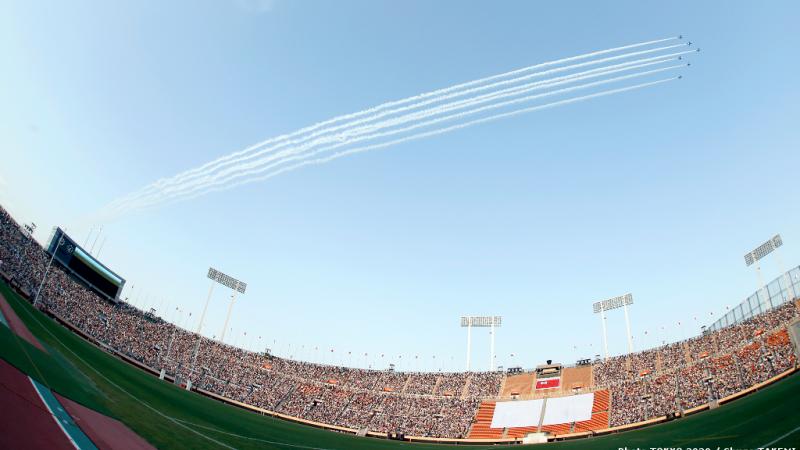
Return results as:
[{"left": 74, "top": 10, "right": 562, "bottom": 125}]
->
[{"left": 0, "top": 208, "right": 797, "bottom": 438}]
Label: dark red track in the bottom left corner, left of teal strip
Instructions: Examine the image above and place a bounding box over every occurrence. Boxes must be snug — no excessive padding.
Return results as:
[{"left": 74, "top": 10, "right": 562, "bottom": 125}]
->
[{"left": 0, "top": 356, "right": 74, "bottom": 450}]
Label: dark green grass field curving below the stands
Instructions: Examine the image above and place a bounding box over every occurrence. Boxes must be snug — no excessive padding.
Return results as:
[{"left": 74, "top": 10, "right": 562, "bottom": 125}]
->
[{"left": 0, "top": 283, "right": 800, "bottom": 450}]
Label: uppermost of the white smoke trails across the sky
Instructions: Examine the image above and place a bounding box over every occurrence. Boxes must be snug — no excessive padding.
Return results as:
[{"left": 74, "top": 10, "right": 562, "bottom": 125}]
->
[{"left": 103, "top": 37, "right": 684, "bottom": 213}]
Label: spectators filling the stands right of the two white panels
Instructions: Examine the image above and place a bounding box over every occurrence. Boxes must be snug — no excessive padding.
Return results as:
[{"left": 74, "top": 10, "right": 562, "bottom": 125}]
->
[{"left": 608, "top": 302, "right": 798, "bottom": 426}]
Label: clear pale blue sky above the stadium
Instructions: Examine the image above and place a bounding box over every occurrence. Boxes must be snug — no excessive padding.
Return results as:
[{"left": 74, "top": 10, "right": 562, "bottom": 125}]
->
[{"left": 0, "top": 0, "right": 800, "bottom": 370}]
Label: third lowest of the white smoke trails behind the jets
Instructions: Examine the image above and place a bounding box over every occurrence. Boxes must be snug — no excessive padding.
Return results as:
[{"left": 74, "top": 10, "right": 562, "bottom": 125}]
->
[{"left": 111, "top": 57, "right": 691, "bottom": 212}]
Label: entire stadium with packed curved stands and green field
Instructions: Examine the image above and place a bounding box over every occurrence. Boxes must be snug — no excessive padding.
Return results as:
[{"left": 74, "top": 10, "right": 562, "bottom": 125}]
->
[{"left": 0, "top": 207, "right": 800, "bottom": 448}]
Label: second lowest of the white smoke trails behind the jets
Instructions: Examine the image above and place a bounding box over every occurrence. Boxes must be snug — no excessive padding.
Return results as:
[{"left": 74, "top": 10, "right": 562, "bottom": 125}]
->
[{"left": 114, "top": 71, "right": 685, "bottom": 212}]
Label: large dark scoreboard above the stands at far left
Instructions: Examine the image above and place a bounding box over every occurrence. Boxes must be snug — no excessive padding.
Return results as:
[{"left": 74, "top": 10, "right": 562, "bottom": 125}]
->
[{"left": 47, "top": 228, "right": 125, "bottom": 301}]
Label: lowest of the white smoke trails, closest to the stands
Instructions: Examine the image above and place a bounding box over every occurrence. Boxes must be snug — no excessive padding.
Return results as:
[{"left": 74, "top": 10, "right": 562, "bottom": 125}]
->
[{"left": 137, "top": 76, "right": 680, "bottom": 209}]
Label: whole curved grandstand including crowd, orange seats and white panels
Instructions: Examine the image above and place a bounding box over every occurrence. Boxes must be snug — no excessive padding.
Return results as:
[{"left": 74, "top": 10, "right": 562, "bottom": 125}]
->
[{"left": 0, "top": 209, "right": 800, "bottom": 443}]
